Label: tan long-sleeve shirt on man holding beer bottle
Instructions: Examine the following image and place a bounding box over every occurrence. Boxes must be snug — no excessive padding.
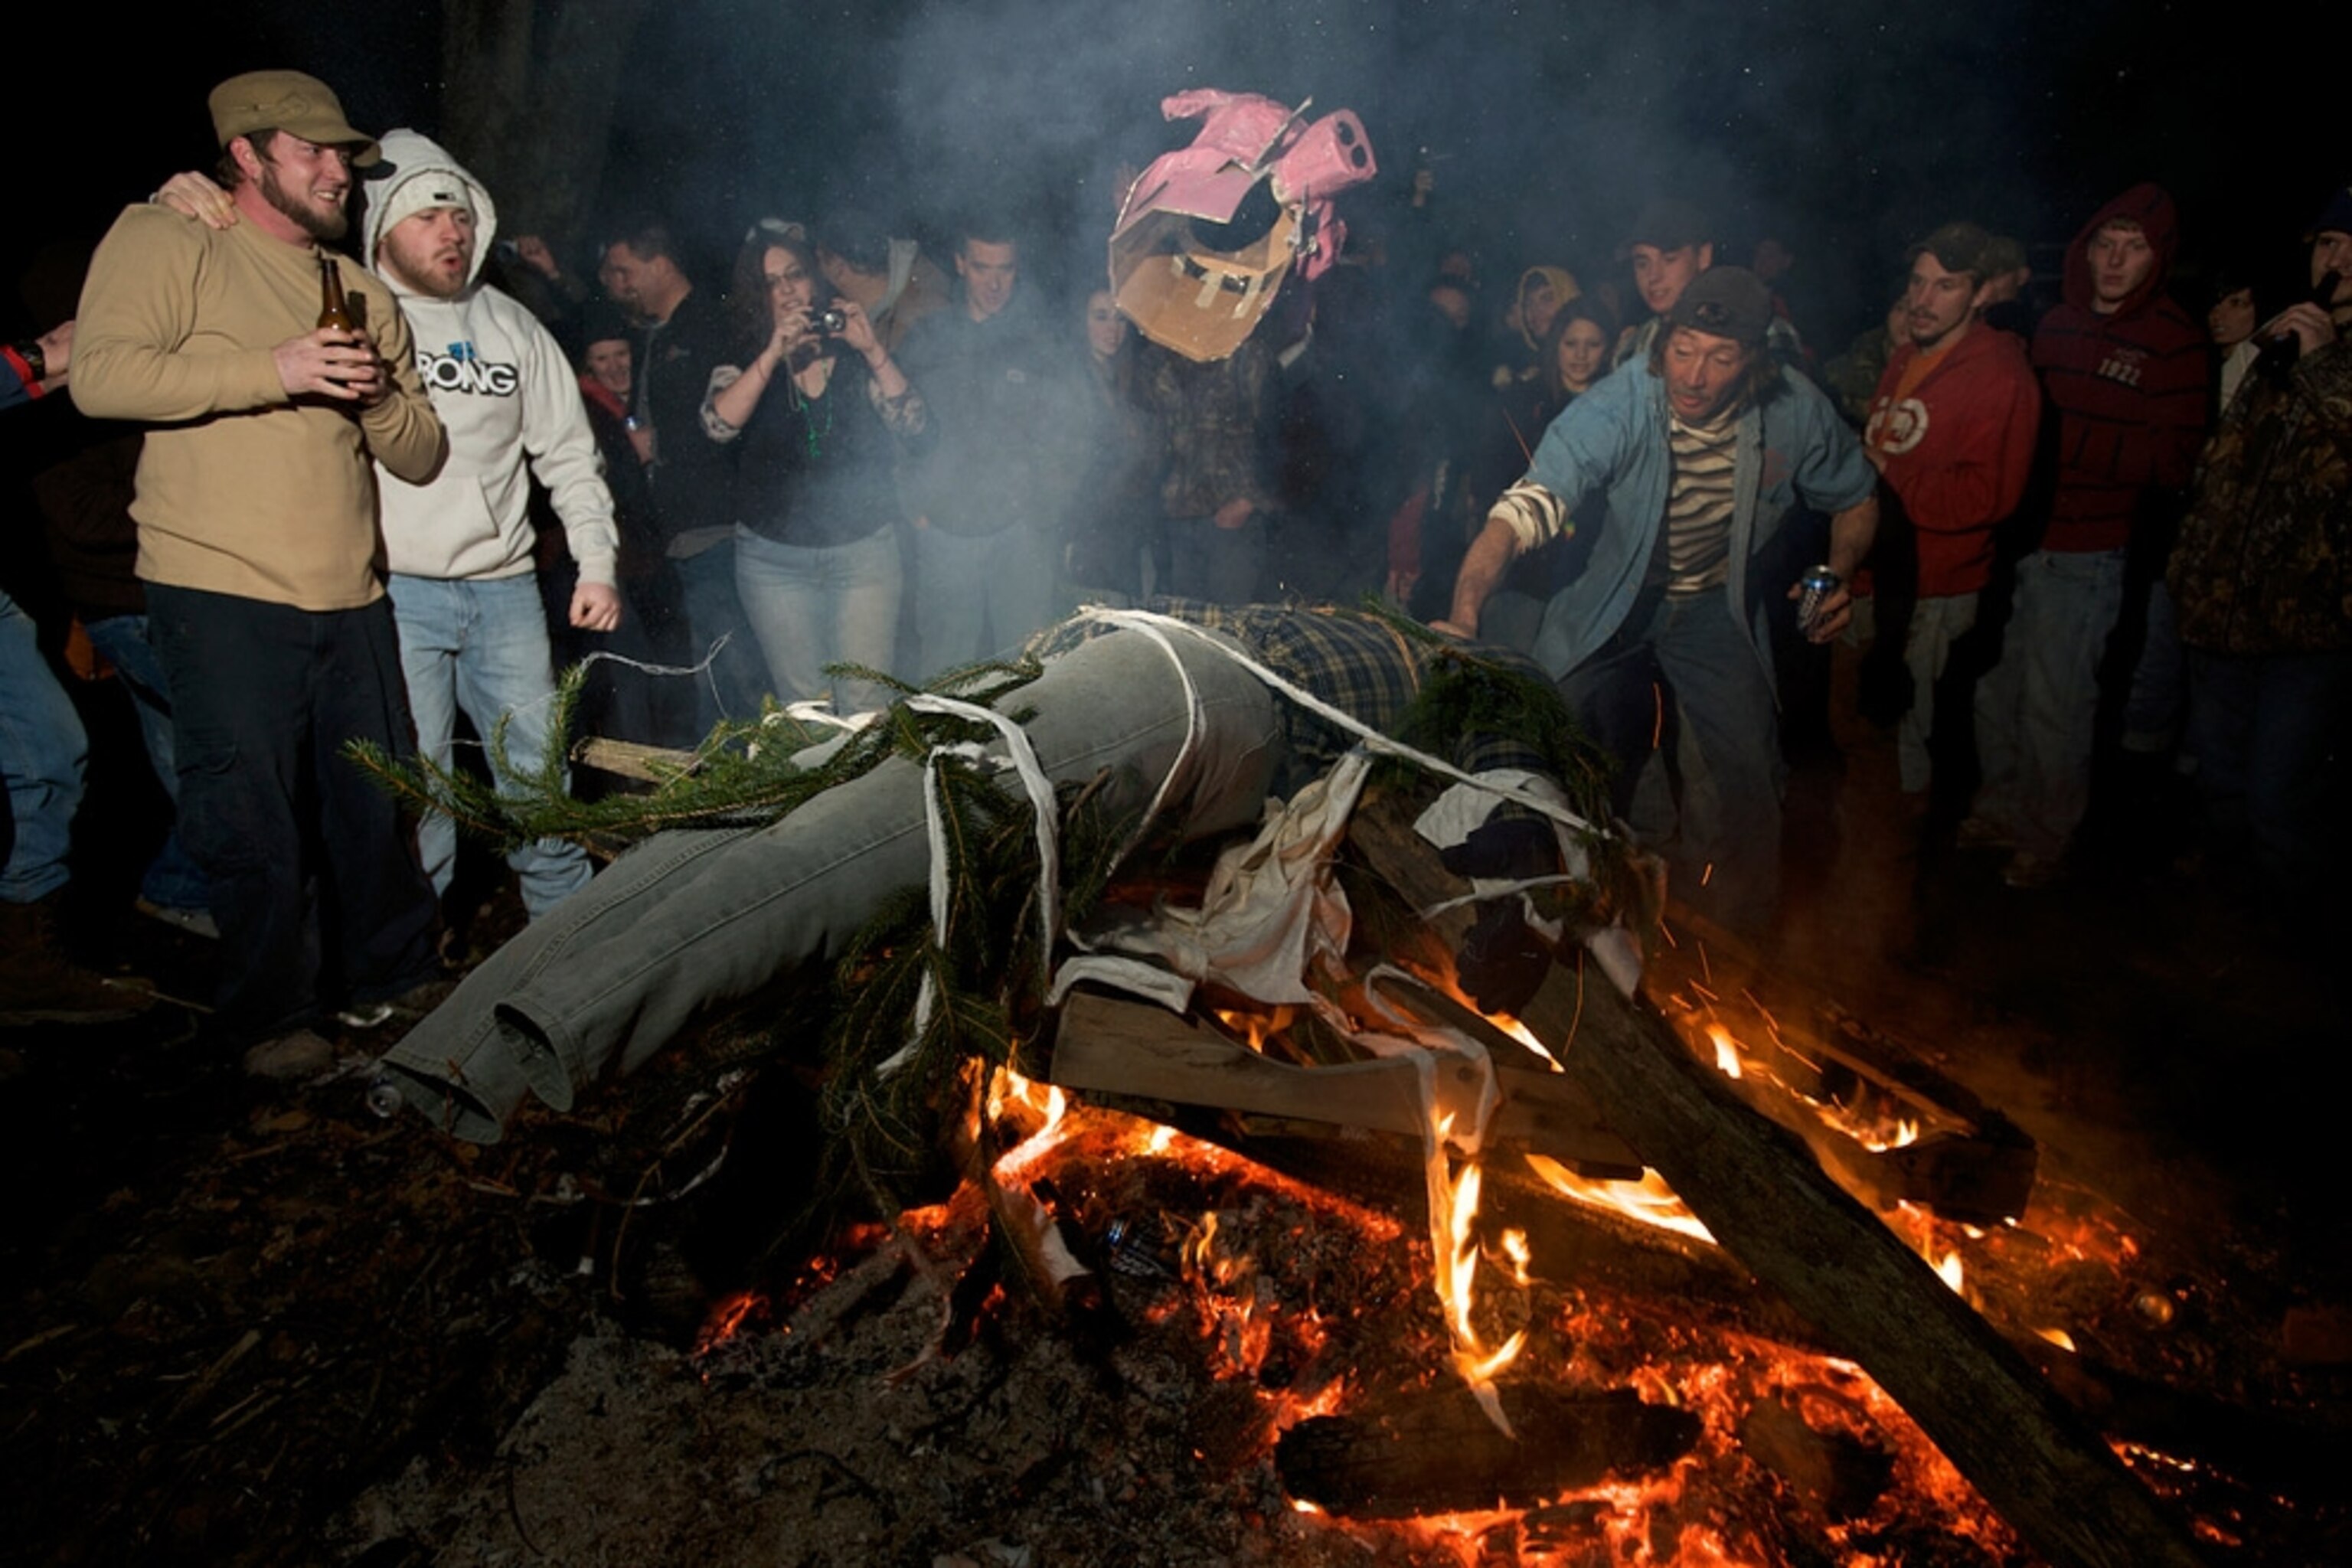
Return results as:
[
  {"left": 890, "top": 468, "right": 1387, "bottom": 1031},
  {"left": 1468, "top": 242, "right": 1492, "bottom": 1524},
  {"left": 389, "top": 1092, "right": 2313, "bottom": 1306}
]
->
[{"left": 68, "top": 207, "right": 445, "bottom": 609}]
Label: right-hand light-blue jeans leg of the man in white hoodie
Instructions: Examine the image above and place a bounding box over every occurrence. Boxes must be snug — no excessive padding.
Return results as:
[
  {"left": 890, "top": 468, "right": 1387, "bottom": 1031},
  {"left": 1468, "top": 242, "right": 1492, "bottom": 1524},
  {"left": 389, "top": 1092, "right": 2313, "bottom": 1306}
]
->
[{"left": 456, "top": 573, "right": 595, "bottom": 920}]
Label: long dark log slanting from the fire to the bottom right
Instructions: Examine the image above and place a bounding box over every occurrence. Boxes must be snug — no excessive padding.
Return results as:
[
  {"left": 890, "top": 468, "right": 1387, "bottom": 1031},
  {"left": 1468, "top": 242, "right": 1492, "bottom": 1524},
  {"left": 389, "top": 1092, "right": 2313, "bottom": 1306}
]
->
[{"left": 1350, "top": 813, "right": 2199, "bottom": 1568}]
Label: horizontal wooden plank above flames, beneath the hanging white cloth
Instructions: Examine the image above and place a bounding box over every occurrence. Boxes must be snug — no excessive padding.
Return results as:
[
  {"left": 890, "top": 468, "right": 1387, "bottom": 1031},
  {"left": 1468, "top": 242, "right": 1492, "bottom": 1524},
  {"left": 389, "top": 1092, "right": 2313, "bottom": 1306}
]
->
[{"left": 1049, "top": 990, "right": 1642, "bottom": 1171}]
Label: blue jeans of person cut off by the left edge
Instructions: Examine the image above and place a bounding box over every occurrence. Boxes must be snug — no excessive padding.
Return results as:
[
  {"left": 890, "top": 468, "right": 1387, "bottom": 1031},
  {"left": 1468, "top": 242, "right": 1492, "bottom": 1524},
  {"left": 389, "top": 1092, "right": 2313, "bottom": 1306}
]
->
[{"left": 0, "top": 593, "right": 90, "bottom": 903}]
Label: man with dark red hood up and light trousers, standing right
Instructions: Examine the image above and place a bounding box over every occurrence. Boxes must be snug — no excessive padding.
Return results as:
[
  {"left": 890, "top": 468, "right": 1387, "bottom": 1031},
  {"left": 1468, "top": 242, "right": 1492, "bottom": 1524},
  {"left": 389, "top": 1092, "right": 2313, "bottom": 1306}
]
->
[{"left": 1962, "top": 186, "right": 2211, "bottom": 889}]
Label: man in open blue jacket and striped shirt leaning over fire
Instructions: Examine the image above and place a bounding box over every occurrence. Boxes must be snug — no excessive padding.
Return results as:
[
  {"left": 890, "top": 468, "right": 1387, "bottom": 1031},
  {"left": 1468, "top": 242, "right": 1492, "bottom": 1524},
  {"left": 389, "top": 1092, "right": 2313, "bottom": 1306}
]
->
[{"left": 1437, "top": 268, "right": 1880, "bottom": 931}]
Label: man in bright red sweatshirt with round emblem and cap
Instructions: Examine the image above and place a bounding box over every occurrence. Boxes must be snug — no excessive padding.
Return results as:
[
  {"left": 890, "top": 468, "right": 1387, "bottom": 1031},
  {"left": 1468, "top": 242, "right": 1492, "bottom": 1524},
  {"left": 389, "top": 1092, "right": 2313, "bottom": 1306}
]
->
[{"left": 1863, "top": 224, "right": 2041, "bottom": 795}]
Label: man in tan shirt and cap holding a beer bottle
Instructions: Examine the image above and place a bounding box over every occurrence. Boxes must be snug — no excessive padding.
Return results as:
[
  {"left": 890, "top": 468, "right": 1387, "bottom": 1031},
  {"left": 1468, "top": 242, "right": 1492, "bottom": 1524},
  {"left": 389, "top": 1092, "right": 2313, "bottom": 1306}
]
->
[{"left": 70, "top": 70, "right": 447, "bottom": 1072}]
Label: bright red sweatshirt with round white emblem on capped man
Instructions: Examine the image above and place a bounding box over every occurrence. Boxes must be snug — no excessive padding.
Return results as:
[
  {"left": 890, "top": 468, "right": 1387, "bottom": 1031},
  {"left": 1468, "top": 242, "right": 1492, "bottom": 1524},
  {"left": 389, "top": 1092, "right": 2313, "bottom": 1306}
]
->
[{"left": 1863, "top": 322, "right": 2041, "bottom": 599}]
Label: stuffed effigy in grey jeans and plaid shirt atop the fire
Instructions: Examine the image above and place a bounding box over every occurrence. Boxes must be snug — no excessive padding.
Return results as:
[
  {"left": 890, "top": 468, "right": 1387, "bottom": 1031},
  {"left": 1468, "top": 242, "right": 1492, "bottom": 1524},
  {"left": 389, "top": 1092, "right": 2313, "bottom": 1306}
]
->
[{"left": 384, "top": 602, "right": 1637, "bottom": 1142}]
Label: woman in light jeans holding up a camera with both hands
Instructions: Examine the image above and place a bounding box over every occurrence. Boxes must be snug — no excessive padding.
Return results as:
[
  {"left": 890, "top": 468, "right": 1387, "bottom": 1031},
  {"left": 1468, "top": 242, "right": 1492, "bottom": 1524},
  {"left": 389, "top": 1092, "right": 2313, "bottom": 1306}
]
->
[{"left": 704, "top": 219, "right": 926, "bottom": 712}]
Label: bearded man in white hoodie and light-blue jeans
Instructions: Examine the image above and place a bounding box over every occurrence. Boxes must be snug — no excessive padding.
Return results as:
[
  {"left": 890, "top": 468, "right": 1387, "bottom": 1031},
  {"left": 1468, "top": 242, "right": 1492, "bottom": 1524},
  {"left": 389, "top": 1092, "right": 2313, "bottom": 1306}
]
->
[{"left": 162, "top": 129, "right": 621, "bottom": 920}]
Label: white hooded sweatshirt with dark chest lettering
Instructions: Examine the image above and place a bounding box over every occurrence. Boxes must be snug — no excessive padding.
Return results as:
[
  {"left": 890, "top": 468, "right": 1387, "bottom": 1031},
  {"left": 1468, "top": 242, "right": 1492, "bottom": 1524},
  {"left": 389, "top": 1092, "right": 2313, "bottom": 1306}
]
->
[{"left": 360, "top": 129, "right": 621, "bottom": 588}]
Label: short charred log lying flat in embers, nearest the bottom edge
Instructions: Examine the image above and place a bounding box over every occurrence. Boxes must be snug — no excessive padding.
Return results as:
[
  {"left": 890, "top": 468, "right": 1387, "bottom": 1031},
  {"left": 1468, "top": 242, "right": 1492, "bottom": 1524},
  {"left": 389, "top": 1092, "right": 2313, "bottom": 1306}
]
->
[{"left": 1275, "top": 1387, "right": 1700, "bottom": 1519}]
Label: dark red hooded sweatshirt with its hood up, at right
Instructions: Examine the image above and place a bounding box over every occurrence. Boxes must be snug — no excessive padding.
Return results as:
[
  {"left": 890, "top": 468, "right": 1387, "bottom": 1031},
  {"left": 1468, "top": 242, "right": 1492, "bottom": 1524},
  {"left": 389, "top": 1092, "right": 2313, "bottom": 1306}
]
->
[{"left": 2034, "top": 186, "right": 2211, "bottom": 550}]
